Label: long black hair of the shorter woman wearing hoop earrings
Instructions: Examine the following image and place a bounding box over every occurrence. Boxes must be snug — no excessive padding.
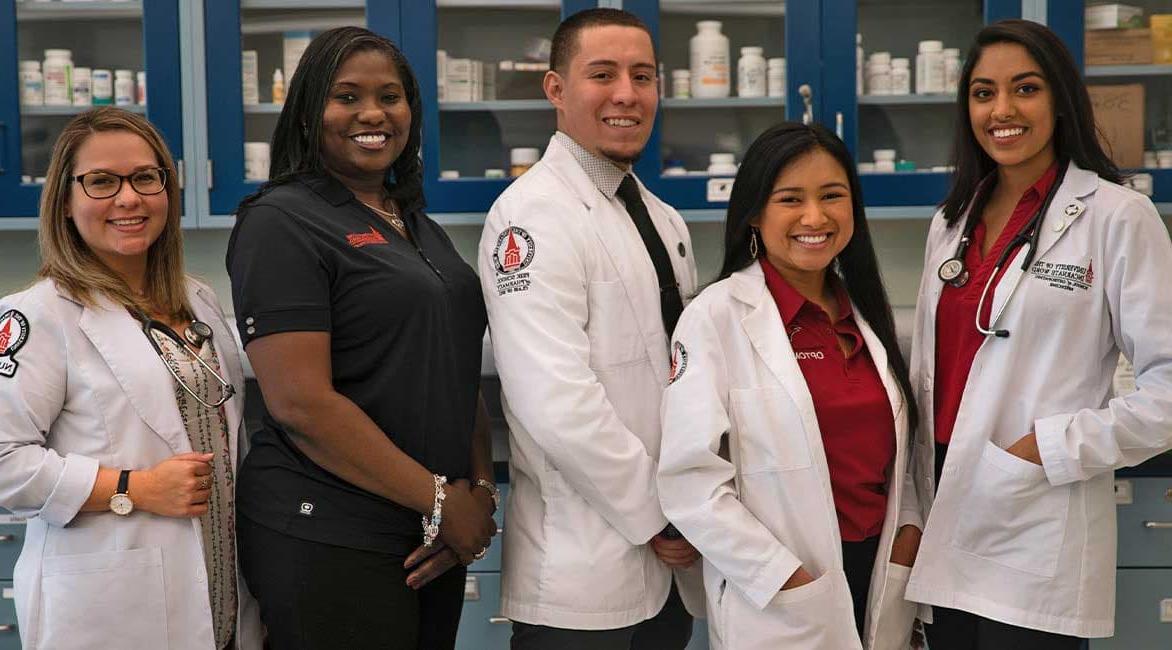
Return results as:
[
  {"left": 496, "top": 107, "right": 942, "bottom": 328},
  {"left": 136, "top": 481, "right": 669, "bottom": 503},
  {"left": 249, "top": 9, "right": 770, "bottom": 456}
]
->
[{"left": 717, "top": 122, "right": 919, "bottom": 433}]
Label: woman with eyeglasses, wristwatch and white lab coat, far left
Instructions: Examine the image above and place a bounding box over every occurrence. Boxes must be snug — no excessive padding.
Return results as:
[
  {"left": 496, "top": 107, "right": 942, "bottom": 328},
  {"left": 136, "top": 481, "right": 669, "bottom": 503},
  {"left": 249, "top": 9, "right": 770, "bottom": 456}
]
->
[{"left": 0, "top": 108, "right": 261, "bottom": 650}]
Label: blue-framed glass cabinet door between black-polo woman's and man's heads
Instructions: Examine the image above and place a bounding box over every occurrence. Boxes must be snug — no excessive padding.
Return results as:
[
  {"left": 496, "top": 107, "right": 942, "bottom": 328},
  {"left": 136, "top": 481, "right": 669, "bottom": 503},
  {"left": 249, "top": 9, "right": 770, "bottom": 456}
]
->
[{"left": 402, "top": 0, "right": 594, "bottom": 220}]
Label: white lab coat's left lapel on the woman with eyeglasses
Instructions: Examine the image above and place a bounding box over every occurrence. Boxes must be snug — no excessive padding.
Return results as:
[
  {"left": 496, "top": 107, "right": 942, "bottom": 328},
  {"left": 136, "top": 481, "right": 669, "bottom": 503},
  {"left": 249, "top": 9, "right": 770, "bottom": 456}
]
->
[{"left": 77, "top": 295, "right": 191, "bottom": 453}]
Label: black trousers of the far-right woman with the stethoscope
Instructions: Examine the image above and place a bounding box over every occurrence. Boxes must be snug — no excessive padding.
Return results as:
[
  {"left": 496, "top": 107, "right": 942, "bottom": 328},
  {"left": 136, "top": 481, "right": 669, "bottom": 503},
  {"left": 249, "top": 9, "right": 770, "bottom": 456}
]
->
[{"left": 925, "top": 443, "right": 1083, "bottom": 650}]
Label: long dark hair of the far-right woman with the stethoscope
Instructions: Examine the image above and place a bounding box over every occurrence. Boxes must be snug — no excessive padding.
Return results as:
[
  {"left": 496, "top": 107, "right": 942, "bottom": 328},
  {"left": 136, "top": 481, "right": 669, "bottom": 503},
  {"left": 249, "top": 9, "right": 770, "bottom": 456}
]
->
[{"left": 941, "top": 19, "right": 1123, "bottom": 226}]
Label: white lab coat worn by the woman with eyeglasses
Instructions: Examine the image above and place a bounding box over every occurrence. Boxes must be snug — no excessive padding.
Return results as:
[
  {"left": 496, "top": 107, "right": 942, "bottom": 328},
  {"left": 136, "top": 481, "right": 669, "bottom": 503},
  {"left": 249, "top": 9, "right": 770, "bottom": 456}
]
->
[{"left": 0, "top": 280, "right": 261, "bottom": 650}]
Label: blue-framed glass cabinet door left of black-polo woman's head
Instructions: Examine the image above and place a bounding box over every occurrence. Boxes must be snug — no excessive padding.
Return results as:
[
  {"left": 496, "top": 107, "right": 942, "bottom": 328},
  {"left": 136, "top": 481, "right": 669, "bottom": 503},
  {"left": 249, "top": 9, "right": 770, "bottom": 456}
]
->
[{"left": 205, "top": 0, "right": 400, "bottom": 215}]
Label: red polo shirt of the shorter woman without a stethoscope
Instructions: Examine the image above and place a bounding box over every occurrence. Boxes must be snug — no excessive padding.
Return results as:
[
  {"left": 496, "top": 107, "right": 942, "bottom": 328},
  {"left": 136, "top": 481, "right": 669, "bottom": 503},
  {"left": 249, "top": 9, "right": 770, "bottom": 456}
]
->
[{"left": 761, "top": 259, "right": 895, "bottom": 541}]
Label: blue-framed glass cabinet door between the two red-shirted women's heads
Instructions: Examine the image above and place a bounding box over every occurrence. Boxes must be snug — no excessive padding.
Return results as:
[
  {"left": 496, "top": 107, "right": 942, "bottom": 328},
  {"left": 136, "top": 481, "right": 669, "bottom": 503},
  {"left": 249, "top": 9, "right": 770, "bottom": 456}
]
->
[{"left": 820, "top": 0, "right": 1021, "bottom": 206}]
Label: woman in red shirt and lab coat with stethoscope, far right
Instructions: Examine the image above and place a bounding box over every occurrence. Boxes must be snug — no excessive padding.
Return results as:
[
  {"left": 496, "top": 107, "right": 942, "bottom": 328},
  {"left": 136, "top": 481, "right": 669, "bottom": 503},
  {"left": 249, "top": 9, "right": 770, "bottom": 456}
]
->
[{"left": 907, "top": 20, "right": 1172, "bottom": 650}]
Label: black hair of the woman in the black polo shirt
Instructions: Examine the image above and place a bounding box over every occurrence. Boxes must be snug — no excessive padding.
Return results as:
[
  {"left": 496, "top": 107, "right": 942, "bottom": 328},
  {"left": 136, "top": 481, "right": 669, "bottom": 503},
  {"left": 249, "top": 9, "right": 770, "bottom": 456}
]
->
[{"left": 240, "top": 27, "right": 425, "bottom": 212}]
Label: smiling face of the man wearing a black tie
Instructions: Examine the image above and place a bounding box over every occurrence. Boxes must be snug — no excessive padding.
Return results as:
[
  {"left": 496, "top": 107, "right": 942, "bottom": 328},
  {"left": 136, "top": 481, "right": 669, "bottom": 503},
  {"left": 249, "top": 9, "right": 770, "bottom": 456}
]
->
[{"left": 545, "top": 25, "right": 659, "bottom": 165}]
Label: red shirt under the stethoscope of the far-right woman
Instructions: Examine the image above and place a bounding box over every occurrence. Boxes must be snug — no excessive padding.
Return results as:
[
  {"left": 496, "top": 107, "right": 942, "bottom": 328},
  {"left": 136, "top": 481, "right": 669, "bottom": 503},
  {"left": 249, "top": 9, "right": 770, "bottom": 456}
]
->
[{"left": 933, "top": 163, "right": 1058, "bottom": 445}]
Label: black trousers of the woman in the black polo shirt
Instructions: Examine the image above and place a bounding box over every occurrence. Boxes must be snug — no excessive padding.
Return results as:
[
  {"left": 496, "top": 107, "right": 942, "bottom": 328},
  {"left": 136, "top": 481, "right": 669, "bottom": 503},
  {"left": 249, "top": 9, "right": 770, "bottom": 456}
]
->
[{"left": 237, "top": 516, "right": 465, "bottom": 650}]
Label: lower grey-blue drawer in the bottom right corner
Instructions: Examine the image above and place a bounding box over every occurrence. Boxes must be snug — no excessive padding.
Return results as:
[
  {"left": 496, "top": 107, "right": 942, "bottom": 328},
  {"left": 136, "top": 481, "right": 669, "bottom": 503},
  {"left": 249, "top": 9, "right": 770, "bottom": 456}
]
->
[{"left": 1090, "top": 568, "right": 1172, "bottom": 650}]
